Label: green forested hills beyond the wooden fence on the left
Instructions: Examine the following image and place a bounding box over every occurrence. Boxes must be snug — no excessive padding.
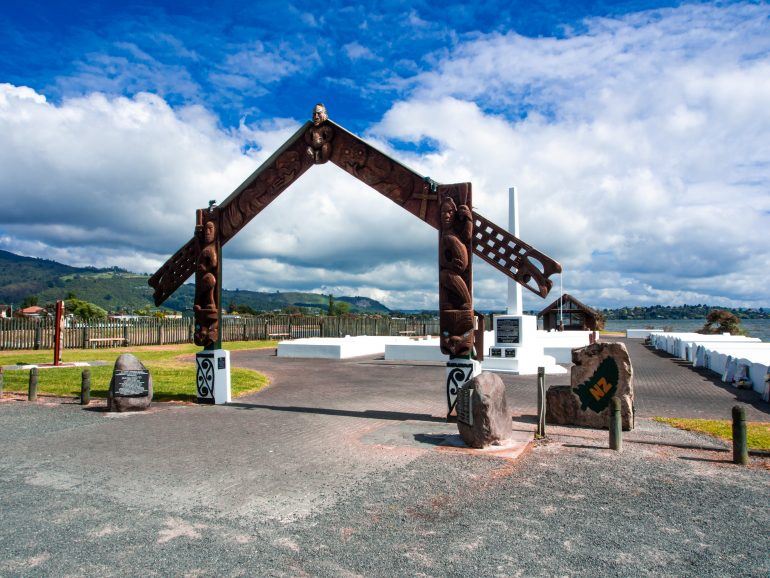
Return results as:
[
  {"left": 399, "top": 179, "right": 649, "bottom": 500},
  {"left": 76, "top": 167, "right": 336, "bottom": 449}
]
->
[{"left": 0, "top": 250, "right": 389, "bottom": 313}]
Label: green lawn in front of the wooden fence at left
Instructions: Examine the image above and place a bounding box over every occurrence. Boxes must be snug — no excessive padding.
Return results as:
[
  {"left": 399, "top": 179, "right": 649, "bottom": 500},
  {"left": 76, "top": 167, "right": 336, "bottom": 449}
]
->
[{"left": 0, "top": 341, "right": 277, "bottom": 401}]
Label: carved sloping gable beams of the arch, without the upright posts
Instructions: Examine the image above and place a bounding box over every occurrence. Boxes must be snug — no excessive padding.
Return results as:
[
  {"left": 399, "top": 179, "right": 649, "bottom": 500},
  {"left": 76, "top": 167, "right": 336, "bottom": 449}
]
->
[{"left": 149, "top": 105, "right": 561, "bottom": 305}]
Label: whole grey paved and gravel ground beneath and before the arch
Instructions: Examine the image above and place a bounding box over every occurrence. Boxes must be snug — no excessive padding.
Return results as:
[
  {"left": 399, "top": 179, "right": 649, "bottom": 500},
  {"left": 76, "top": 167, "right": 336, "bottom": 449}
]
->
[{"left": 0, "top": 336, "right": 770, "bottom": 576}]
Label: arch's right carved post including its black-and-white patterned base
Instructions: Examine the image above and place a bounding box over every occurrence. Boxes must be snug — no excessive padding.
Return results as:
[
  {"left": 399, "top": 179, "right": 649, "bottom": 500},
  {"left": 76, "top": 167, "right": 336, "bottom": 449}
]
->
[{"left": 430, "top": 183, "right": 481, "bottom": 419}]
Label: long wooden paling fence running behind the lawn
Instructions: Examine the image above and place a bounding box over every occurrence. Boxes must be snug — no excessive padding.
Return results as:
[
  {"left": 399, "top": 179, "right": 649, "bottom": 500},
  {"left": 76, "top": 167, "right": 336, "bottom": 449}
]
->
[{"left": 0, "top": 315, "right": 472, "bottom": 350}]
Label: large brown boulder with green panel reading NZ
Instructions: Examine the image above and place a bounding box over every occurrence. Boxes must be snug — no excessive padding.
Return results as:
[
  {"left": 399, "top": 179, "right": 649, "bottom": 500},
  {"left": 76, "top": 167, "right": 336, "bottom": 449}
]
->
[{"left": 546, "top": 342, "right": 634, "bottom": 431}]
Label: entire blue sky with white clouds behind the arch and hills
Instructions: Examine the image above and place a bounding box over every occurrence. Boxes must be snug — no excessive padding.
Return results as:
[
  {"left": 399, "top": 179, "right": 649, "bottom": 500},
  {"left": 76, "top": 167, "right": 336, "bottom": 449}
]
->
[{"left": 0, "top": 0, "right": 770, "bottom": 309}]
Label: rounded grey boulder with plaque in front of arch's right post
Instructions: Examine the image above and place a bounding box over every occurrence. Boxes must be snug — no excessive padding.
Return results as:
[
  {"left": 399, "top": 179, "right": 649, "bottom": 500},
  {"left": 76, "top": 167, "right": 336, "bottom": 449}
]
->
[{"left": 457, "top": 371, "right": 513, "bottom": 449}]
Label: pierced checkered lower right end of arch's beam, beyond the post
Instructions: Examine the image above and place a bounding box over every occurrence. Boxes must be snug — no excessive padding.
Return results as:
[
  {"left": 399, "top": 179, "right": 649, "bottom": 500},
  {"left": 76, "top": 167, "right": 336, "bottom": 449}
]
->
[{"left": 473, "top": 212, "right": 561, "bottom": 297}]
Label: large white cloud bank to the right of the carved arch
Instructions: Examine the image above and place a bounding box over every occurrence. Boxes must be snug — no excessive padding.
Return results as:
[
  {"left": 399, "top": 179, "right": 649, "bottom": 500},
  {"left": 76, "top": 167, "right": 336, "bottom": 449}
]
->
[{"left": 373, "top": 5, "right": 770, "bottom": 306}]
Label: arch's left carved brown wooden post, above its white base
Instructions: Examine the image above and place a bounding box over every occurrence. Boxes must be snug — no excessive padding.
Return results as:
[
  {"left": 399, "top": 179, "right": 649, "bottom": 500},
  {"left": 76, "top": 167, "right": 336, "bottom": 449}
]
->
[{"left": 193, "top": 207, "right": 219, "bottom": 347}]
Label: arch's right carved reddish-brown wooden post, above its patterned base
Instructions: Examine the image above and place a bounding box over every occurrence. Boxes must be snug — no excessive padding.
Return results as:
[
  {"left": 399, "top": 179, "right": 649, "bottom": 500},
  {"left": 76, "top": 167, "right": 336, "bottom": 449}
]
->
[{"left": 438, "top": 184, "right": 474, "bottom": 357}]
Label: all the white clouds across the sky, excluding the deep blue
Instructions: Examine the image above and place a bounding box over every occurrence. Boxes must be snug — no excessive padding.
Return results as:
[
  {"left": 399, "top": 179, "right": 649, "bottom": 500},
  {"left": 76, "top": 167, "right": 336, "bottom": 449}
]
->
[{"left": 0, "top": 5, "right": 770, "bottom": 308}]
